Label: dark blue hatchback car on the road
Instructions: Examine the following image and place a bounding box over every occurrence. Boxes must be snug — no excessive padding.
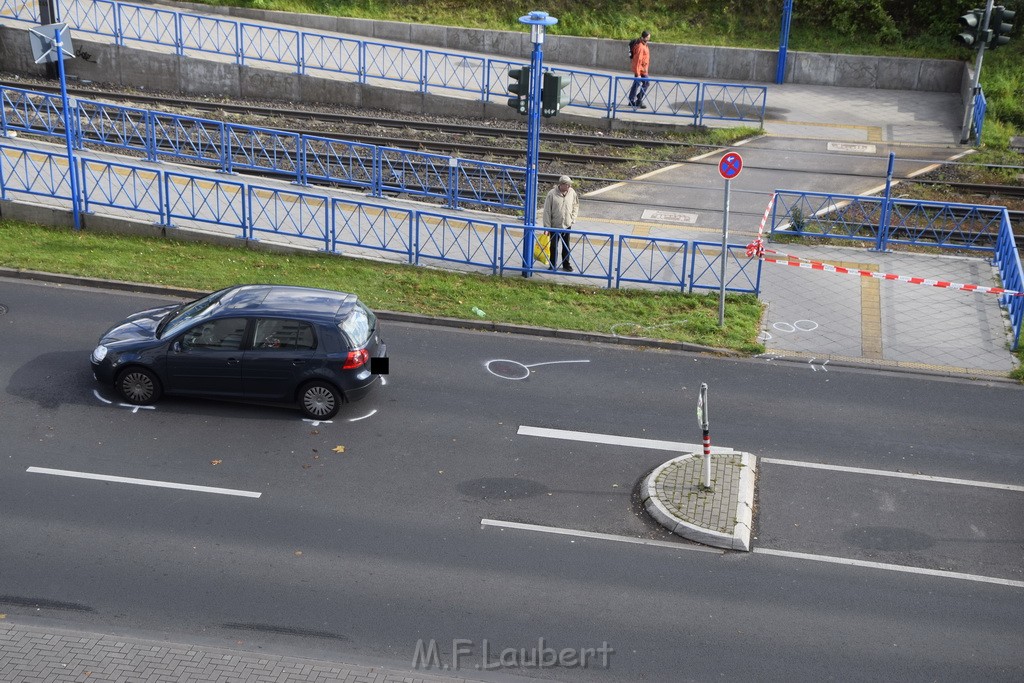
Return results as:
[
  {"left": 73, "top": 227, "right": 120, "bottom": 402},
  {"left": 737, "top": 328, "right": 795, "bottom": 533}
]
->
[{"left": 91, "top": 285, "right": 388, "bottom": 420}]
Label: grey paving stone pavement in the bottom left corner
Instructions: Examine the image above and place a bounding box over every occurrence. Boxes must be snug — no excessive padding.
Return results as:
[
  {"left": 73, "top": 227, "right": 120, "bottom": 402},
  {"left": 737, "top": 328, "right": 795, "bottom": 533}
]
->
[{"left": 0, "top": 621, "right": 468, "bottom": 683}]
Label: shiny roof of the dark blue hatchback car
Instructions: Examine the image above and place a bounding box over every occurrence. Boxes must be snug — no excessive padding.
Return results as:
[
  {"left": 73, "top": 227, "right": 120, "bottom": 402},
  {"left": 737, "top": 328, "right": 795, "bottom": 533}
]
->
[{"left": 217, "top": 285, "right": 358, "bottom": 322}]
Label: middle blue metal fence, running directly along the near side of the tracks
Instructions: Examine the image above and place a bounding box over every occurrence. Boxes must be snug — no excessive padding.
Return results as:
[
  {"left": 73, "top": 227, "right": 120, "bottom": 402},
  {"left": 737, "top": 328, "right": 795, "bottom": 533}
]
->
[{"left": 0, "top": 87, "right": 526, "bottom": 211}]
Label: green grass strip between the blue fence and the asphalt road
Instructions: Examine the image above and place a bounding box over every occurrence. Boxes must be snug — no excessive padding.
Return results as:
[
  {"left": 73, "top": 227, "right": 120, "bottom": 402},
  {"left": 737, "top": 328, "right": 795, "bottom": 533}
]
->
[{"left": 0, "top": 220, "right": 764, "bottom": 353}]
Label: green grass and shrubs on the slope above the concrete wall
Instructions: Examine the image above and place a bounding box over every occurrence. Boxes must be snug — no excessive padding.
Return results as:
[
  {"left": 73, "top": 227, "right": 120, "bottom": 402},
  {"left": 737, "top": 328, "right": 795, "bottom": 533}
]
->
[{"left": 192, "top": 0, "right": 1024, "bottom": 144}]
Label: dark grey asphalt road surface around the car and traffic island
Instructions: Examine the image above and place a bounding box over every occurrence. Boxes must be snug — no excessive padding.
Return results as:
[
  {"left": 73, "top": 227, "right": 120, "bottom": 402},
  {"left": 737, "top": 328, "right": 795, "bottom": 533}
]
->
[{"left": 0, "top": 280, "right": 1024, "bottom": 681}]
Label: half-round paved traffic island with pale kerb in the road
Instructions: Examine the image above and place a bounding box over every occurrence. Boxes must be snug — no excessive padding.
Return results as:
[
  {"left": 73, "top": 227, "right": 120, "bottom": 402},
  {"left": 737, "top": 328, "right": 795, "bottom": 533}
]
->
[{"left": 641, "top": 452, "right": 757, "bottom": 551}]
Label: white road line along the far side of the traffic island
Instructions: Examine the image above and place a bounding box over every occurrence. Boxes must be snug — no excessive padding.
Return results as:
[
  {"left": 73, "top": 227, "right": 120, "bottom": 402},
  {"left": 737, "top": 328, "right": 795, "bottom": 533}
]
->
[{"left": 517, "top": 425, "right": 1024, "bottom": 493}]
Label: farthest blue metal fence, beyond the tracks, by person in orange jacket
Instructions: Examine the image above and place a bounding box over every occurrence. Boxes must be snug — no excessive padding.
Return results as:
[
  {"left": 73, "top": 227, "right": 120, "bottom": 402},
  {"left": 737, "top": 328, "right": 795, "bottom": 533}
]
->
[{"left": 0, "top": 0, "right": 768, "bottom": 125}]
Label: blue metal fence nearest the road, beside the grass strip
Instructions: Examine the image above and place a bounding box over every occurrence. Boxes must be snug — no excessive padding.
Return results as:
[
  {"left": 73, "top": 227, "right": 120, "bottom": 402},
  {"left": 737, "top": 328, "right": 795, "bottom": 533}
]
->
[{"left": 0, "top": 143, "right": 761, "bottom": 294}]
